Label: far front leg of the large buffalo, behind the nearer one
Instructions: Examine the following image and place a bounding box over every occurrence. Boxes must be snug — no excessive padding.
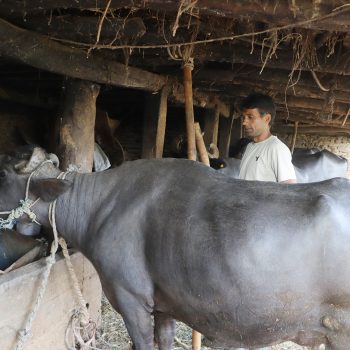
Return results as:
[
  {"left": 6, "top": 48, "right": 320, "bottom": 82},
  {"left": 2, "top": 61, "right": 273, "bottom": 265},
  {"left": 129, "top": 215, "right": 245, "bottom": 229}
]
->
[{"left": 154, "top": 312, "right": 175, "bottom": 350}]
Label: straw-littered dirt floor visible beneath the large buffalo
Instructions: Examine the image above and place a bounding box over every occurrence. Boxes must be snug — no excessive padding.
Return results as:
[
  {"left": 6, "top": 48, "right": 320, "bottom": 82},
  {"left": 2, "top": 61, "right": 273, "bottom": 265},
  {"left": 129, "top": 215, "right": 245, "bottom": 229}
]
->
[{"left": 97, "top": 298, "right": 307, "bottom": 350}]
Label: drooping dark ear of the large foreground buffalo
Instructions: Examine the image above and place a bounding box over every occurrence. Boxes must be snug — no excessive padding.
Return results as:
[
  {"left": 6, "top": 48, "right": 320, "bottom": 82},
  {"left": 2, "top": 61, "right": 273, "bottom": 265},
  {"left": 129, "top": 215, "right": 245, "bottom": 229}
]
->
[{"left": 29, "top": 179, "right": 73, "bottom": 202}]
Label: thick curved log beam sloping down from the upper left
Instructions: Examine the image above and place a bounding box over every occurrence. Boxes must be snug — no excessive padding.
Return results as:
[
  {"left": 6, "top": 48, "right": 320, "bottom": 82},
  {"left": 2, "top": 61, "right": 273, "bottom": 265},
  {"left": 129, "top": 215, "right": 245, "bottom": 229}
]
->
[{"left": 0, "top": 19, "right": 229, "bottom": 116}]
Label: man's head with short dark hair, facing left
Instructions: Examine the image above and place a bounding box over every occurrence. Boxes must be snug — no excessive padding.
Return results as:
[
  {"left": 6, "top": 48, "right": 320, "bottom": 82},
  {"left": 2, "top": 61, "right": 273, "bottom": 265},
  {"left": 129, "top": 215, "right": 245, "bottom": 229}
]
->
[{"left": 240, "top": 93, "right": 276, "bottom": 142}]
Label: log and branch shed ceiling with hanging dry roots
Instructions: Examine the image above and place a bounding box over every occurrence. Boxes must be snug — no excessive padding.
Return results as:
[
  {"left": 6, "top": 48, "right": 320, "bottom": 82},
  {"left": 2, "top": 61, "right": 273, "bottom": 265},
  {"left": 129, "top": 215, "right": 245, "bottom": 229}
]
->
[{"left": 0, "top": 0, "right": 350, "bottom": 135}]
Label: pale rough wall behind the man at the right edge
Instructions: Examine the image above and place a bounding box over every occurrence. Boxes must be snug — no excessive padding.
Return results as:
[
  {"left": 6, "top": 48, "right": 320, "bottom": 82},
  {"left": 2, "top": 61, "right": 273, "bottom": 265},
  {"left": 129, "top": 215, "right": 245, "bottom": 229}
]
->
[{"left": 277, "top": 134, "right": 350, "bottom": 178}]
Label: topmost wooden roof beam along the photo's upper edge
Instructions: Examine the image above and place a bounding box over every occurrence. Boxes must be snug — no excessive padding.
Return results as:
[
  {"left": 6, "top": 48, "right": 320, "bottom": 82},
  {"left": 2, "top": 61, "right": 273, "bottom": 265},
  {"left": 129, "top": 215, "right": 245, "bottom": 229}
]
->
[{"left": 0, "top": 0, "right": 350, "bottom": 32}]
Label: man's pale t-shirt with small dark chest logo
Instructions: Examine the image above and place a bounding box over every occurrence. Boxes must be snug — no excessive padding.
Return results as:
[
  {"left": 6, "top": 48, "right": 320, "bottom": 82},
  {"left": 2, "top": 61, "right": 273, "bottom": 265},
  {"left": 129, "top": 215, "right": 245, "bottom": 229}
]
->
[{"left": 239, "top": 136, "right": 296, "bottom": 182}]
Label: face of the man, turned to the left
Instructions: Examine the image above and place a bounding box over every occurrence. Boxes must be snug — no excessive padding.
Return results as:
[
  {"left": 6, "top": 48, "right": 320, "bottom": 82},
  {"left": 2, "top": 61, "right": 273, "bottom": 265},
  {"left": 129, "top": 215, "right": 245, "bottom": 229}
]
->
[{"left": 242, "top": 108, "right": 271, "bottom": 141}]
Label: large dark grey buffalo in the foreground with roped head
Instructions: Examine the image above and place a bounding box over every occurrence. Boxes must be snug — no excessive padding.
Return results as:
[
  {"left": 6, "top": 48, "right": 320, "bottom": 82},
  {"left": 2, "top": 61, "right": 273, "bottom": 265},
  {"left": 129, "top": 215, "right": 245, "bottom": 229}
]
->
[{"left": 0, "top": 151, "right": 350, "bottom": 350}]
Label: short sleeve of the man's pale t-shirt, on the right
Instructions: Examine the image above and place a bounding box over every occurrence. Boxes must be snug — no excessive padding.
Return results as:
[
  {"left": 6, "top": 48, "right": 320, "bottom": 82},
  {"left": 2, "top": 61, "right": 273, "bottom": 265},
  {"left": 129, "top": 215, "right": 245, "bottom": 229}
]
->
[{"left": 273, "top": 142, "right": 296, "bottom": 182}]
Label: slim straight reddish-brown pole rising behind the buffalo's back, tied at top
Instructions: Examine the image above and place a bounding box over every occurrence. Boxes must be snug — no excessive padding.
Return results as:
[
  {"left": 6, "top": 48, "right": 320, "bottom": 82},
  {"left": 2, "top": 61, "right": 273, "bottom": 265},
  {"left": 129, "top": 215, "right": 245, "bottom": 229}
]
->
[{"left": 183, "top": 64, "right": 196, "bottom": 160}]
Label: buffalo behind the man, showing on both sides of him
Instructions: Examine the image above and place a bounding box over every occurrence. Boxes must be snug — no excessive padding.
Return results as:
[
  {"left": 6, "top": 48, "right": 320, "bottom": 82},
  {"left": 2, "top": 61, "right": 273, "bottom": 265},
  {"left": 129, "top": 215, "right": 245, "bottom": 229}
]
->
[{"left": 210, "top": 150, "right": 348, "bottom": 183}]
